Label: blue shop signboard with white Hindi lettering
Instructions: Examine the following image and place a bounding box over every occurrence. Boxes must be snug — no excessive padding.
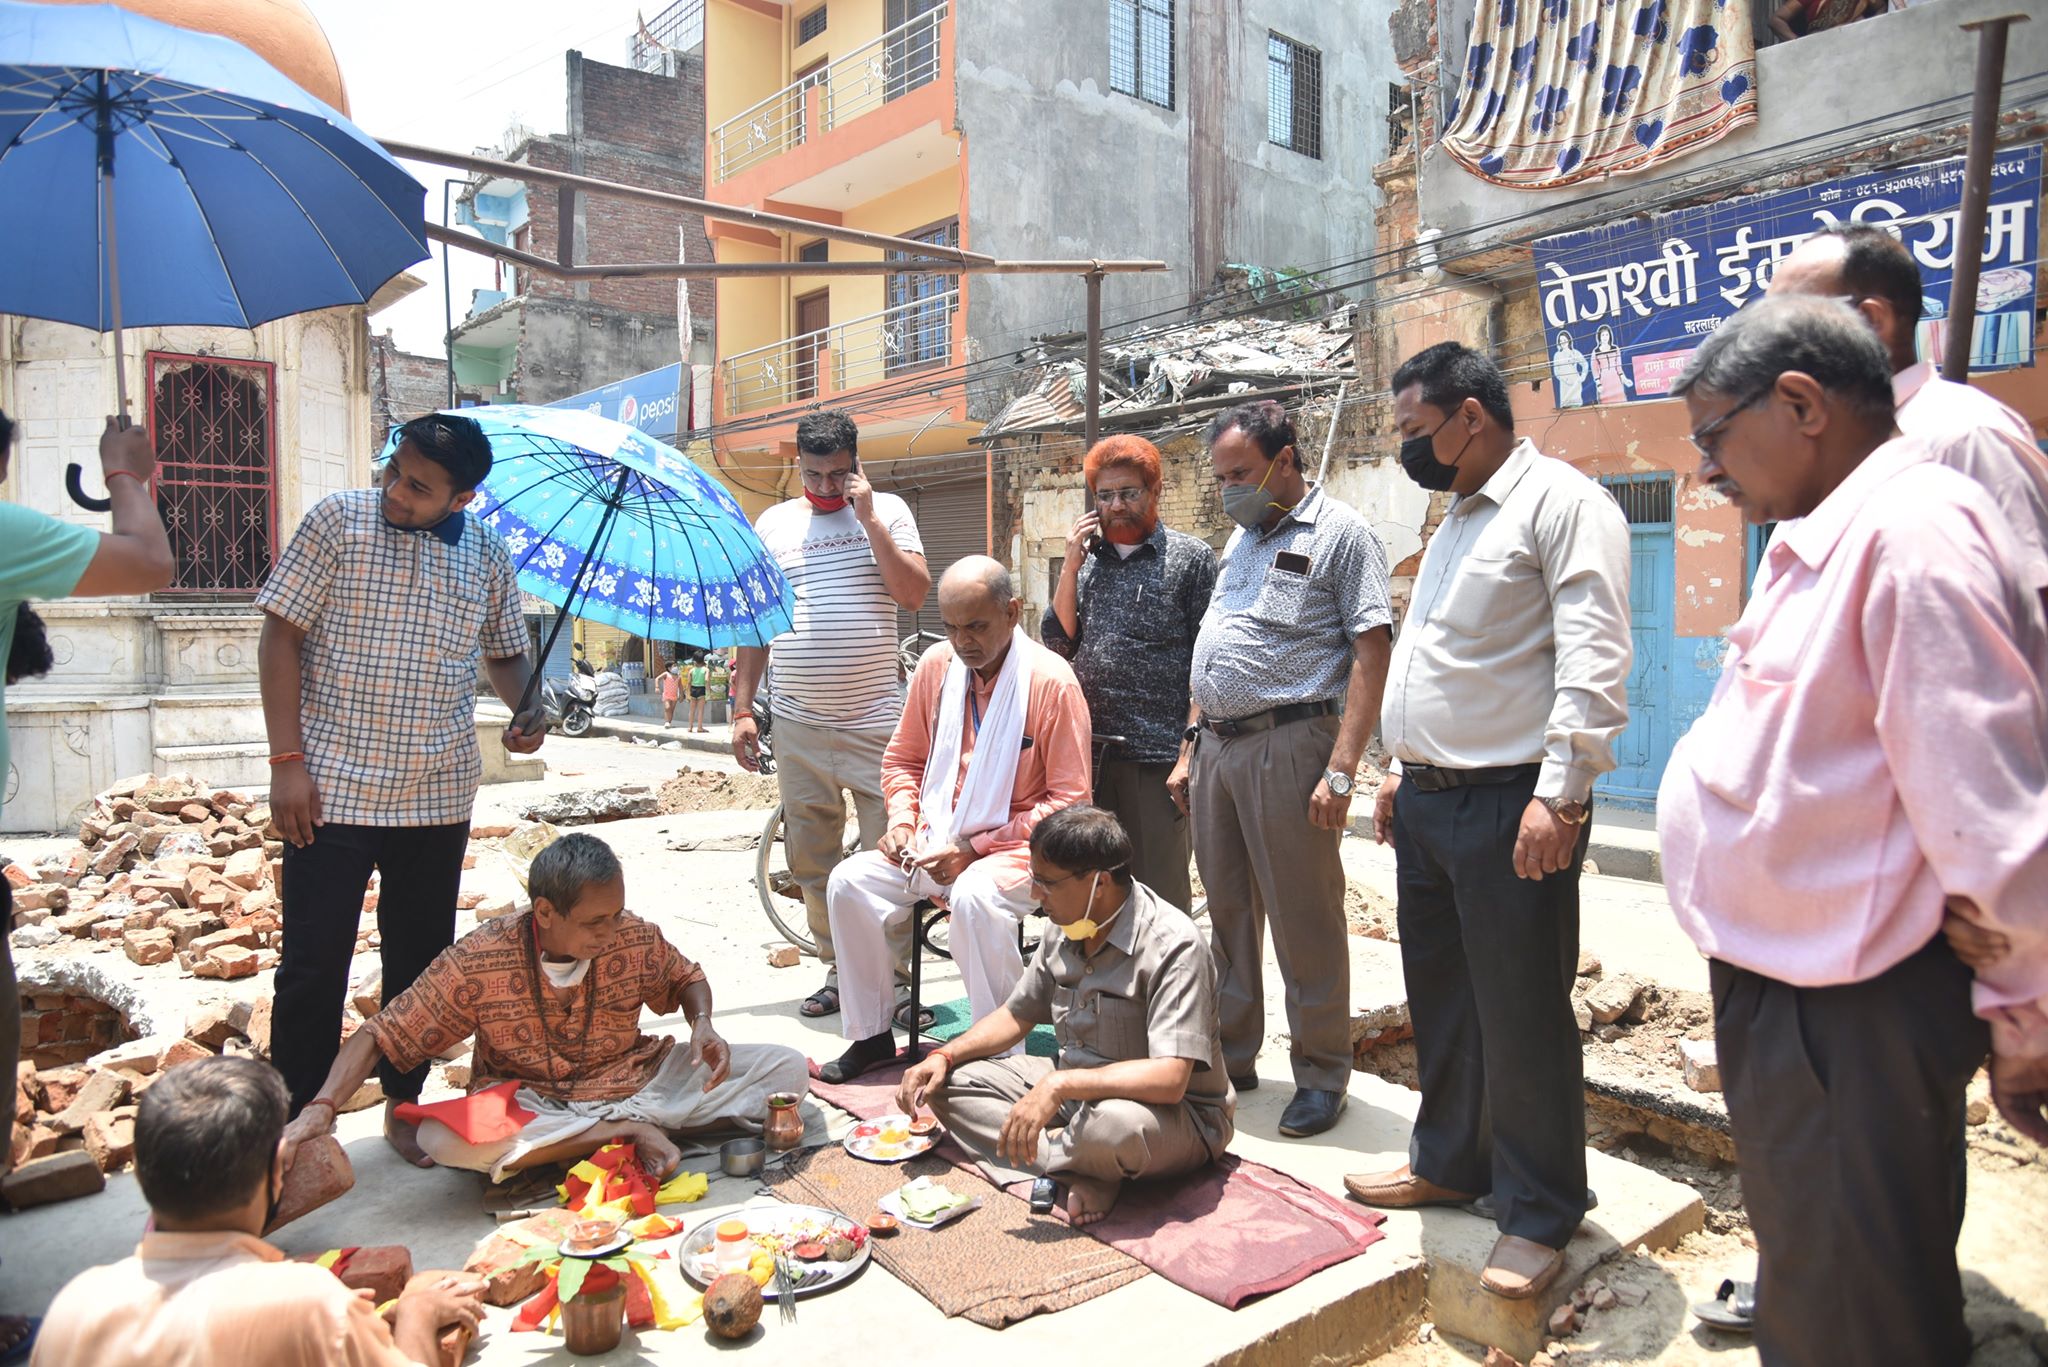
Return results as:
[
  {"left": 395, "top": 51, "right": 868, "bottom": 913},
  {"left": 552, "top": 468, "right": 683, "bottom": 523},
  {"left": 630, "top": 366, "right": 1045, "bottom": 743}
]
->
[{"left": 1536, "top": 146, "right": 2042, "bottom": 408}]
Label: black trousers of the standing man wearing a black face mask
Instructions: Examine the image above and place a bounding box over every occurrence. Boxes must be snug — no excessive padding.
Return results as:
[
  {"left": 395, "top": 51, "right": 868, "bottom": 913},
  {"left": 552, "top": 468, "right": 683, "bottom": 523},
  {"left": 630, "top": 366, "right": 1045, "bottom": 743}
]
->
[{"left": 1393, "top": 775, "right": 1591, "bottom": 1248}]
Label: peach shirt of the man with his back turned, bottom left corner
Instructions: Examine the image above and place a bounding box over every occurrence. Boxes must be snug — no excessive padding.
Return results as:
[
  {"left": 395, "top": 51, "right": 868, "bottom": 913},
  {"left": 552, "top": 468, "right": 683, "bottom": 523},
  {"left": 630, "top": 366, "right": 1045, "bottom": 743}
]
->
[{"left": 29, "top": 1232, "right": 412, "bottom": 1367}]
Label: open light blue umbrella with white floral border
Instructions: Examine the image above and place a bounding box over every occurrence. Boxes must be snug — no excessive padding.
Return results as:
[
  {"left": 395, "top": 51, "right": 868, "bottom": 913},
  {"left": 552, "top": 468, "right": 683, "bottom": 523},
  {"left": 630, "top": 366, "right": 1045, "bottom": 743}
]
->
[{"left": 383, "top": 404, "right": 797, "bottom": 693}]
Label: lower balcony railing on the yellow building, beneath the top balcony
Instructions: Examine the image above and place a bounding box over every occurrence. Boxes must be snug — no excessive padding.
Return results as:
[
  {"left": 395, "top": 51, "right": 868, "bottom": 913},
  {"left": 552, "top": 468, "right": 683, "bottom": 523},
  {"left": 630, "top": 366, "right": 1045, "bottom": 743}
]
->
[{"left": 719, "top": 289, "right": 961, "bottom": 418}]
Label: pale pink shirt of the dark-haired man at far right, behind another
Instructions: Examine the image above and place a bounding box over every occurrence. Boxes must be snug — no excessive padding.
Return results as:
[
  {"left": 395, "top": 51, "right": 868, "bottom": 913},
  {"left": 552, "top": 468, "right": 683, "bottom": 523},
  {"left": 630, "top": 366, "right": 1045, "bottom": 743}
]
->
[{"left": 1892, "top": 361, "right": 2048, "bottom": 590}]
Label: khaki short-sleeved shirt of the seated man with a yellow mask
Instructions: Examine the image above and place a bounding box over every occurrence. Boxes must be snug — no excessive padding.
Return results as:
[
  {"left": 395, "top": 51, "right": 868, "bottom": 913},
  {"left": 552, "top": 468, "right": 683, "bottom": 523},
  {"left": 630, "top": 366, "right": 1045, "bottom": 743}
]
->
[{"left": 1008, "top": 883, "right": 1237, "bottom": 1158}]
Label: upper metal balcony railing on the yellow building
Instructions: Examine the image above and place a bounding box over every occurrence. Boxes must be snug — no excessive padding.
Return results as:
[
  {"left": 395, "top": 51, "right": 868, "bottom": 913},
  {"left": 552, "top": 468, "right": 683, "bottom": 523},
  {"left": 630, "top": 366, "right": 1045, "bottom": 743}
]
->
[{"left": 711, "top": 4, "right": 950, "bottom": 180}]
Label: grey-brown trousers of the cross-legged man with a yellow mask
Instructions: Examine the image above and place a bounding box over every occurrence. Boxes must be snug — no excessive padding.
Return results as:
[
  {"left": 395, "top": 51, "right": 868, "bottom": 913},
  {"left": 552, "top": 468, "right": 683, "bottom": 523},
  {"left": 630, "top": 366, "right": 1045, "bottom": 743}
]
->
[{"left": 932, "top": 1053, "right": 1212, "bottom": 1185}]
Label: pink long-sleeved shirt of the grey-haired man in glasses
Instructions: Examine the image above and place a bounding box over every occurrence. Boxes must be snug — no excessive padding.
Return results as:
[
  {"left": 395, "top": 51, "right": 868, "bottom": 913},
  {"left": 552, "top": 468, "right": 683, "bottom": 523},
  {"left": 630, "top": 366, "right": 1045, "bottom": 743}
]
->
[{"left": 1657, "top": 437, "right": 2048, "bottom": 1055}]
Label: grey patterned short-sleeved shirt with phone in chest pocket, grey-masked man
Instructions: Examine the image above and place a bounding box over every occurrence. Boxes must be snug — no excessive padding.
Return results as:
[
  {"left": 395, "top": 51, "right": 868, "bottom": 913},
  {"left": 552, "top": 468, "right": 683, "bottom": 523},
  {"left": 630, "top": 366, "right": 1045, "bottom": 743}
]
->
[{"left": 1194, "top": 486, "right": 1393, "bottom": 721}]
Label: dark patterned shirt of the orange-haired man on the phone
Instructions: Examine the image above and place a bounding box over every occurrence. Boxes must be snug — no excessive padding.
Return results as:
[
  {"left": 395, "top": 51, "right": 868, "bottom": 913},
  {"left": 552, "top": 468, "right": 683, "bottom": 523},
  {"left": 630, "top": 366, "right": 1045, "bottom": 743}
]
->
[{"left": 1038, "top": 523, "right": 1217, "bottom": 764}]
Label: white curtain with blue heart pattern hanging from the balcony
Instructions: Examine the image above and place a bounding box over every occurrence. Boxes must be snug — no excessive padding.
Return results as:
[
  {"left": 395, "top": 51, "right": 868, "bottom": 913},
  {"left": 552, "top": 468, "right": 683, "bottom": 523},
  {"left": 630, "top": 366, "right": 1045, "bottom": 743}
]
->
[{"left": 1444, "top": 0, "right": 1757, "bottom": 191}]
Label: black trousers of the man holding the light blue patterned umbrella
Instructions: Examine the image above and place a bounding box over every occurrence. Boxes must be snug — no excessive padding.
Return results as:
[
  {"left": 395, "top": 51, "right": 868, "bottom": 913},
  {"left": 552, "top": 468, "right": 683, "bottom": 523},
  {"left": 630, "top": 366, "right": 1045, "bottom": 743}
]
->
[{"left": 270, "top": 822, "right": 469, "bottom": 1115}]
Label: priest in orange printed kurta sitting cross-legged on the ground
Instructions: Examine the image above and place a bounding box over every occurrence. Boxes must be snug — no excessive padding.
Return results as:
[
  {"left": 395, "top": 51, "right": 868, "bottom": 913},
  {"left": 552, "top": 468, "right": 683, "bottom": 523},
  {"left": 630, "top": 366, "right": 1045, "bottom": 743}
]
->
[{"left": 285, "top": 834, "right": 809, "bottom": 1180}]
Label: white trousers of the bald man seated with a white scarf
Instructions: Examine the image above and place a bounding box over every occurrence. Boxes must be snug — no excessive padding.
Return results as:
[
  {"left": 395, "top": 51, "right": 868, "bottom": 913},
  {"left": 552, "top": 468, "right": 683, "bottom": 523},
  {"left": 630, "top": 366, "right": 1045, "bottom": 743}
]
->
[{"left": 825, "top": 851, "right": 1030, "bottom": 1039}]
